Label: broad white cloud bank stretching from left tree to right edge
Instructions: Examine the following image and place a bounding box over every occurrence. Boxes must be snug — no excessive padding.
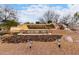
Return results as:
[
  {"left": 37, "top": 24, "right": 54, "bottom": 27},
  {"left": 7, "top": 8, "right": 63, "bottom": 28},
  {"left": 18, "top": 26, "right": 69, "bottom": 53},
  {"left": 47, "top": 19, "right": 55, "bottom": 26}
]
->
[{"left": 18, "top": 4, "right": 79, "bottom": 22}]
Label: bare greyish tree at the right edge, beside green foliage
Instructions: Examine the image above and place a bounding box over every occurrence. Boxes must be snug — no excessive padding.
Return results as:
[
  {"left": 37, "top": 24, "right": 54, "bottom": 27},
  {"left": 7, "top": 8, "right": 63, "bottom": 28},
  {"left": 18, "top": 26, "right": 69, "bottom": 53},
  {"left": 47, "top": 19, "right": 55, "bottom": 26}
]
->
[{"left": 60, "top": 12, "right": 79, "bottom": 28}]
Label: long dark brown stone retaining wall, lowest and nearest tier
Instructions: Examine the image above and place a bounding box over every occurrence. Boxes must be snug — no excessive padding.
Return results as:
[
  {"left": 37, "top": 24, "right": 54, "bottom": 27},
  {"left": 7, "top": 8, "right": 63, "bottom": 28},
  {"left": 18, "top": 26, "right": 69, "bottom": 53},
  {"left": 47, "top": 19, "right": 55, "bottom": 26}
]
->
[{"left": 2, "top": 35, "right": 62, "bottom": 43}]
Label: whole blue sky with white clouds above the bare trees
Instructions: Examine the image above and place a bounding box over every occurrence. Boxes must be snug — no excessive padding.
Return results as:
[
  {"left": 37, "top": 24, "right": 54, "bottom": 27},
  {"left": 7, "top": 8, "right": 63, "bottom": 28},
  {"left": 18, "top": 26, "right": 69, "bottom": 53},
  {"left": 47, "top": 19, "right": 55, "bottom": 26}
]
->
[{"left": 0, "top": 4, "right": 79, "bottom": 23}]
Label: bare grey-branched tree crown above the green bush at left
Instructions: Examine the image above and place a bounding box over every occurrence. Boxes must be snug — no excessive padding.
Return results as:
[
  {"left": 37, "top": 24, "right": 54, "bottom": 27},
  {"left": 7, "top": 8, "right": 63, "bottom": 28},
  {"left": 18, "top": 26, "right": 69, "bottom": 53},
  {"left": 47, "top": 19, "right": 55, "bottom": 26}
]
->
[{"left": 0, "top": 6, "right": 17, "bottom": 22}]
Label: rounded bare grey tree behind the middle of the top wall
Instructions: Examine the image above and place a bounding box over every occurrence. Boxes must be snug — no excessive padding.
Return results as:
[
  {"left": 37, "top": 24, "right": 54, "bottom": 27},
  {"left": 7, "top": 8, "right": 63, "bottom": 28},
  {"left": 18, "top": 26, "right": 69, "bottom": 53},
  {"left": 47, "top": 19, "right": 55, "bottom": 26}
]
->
[{"left": 39, "top": 10, "right": 60, "bottom": 23}]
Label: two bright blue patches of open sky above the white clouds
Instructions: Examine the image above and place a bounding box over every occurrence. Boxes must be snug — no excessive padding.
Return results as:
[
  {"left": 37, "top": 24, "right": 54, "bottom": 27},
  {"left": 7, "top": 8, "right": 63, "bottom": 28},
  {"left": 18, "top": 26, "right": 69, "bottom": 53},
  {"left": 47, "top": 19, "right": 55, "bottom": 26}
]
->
[{"left": 8, "top": 4, "right": 68, "bottom": 10}]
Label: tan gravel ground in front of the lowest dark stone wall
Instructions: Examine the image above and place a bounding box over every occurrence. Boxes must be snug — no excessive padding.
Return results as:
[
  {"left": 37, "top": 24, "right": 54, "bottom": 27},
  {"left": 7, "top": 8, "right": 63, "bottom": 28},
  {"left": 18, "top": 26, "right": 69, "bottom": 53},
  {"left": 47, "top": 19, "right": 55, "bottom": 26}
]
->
[{"left": 0, "top": 32, "right": 79, "bottom": 55}]
